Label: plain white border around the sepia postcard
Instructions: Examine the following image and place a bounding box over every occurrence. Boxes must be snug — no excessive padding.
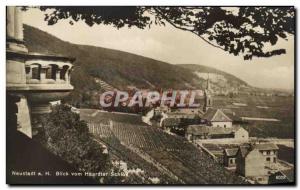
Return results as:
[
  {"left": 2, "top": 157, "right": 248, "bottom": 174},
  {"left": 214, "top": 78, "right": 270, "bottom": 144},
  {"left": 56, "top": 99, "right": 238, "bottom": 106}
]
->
[{"left": 0, "top": 0, "right": 300, "bottom": 189}]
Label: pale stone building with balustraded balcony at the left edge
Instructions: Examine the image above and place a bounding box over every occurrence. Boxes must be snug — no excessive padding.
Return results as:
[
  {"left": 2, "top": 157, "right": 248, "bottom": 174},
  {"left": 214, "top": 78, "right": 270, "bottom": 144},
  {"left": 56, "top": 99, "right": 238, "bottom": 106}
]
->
[{"left": 6, "top": 6, "right": 74, "bottom": 137}]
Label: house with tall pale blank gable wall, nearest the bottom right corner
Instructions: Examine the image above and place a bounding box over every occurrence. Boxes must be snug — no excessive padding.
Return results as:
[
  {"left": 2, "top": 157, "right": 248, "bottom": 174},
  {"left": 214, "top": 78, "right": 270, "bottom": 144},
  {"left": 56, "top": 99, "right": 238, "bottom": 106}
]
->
[{"left": 236, "top": 146, "right": 268, "bottom": 184}]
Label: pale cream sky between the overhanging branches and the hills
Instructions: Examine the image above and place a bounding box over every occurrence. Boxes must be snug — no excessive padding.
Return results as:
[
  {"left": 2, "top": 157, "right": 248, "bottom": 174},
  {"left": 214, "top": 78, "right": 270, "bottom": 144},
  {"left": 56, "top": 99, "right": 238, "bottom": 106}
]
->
[{"left": 23, "top": 9, "right": 294, "bottom": 89}]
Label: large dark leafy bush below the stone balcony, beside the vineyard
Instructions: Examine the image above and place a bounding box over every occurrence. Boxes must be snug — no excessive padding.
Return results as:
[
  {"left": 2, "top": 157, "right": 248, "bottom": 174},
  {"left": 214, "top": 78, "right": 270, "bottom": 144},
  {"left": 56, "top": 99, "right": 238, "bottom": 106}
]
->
[{"left": 39, "top": 105, "right": 109, "bottom": 180}]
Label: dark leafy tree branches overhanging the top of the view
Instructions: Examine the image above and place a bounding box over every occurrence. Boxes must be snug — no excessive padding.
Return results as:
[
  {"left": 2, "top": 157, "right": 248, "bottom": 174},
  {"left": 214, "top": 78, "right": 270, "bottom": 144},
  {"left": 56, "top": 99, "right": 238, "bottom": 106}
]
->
[{"left": 31, "top": 6, "right": 295, "bottom": 60}]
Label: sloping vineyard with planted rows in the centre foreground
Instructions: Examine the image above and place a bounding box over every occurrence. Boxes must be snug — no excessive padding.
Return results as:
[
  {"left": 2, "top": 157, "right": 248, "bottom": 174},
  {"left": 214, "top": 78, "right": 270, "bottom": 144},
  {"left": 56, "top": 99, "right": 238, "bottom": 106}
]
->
[{"left": 81, "top": 108, "right": 244, "bottom": 184}]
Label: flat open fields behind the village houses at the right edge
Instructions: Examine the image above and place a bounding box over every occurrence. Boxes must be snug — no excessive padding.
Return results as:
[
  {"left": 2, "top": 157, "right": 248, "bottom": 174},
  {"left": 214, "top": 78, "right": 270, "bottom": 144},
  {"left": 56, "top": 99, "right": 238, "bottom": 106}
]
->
[{"left": 213, "top": 95, "right": 295, "bottom": 138}]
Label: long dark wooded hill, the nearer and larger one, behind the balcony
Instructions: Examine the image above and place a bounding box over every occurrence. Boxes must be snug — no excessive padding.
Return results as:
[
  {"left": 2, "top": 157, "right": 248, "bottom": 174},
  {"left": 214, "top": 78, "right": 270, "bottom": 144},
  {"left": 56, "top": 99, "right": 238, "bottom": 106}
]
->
[{"left": 24, "top": 25, "right": 202, "bottom": 88}]
